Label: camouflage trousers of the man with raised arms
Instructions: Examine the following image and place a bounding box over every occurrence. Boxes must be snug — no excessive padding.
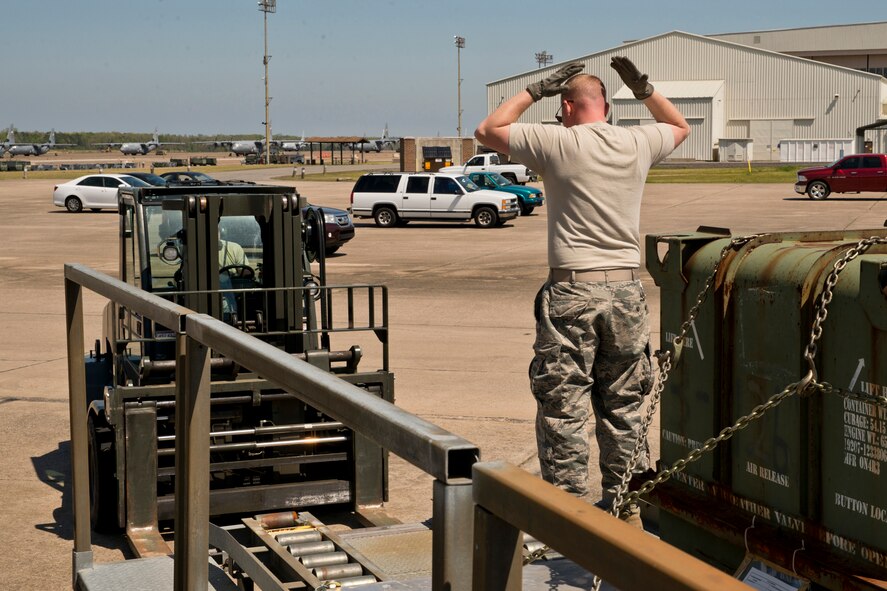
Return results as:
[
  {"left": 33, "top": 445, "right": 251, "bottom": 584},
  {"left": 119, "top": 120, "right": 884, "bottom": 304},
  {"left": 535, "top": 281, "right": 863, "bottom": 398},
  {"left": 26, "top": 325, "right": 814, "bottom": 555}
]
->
[{"left": 530, "top": 281, "right": 653, "bottom": 501}]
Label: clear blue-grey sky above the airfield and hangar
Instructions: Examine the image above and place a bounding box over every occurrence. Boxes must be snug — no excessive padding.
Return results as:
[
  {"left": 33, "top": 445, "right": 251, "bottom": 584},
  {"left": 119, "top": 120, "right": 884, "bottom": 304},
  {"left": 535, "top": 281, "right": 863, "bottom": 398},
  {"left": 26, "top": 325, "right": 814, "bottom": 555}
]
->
[{"left": 6, "top": 0, "right": 887, "bottom": 138}]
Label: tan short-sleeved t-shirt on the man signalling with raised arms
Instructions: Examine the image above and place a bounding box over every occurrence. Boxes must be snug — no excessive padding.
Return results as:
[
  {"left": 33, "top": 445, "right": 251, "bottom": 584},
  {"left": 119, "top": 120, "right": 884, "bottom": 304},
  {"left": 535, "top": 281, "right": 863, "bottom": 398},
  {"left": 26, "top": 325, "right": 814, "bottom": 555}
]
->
[{"left": 509, "top": 122, "right": 674, "bottom": 271}]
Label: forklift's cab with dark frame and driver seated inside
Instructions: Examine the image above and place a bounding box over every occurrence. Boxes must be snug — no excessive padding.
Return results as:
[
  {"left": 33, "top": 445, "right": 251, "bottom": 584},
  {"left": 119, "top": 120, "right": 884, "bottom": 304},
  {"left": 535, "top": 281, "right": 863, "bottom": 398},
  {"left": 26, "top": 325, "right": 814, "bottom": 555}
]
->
[{"left": 119, "top": 185, "right": 325, "bottom": 374}]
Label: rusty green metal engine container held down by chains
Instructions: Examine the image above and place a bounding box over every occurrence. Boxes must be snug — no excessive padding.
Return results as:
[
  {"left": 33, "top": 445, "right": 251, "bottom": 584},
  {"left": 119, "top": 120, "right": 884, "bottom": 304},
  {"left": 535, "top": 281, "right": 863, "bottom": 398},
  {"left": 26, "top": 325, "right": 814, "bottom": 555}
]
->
[{"left": 647, "top": 229, "right": 887, "bottom": 589}]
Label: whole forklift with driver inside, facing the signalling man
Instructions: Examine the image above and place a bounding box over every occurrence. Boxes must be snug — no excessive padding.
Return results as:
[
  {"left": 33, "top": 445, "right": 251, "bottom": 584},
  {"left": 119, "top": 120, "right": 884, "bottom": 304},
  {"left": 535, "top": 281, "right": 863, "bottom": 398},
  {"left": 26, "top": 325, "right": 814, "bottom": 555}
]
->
[{"left": 86, "top": 185, "right": 394, "bottom": 544}]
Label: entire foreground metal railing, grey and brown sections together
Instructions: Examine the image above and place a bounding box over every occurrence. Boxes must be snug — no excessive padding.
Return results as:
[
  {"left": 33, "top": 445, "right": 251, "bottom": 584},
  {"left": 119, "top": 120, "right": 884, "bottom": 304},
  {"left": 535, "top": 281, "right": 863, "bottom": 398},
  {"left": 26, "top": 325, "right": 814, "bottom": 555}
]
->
[{"left": 65, "top": 264, "right": 748, "bottom": 591}]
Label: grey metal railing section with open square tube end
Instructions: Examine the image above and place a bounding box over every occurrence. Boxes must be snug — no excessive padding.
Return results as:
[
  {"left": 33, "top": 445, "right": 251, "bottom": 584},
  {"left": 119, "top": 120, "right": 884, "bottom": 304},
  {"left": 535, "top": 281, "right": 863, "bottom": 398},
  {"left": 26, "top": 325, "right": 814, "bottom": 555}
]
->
[{"left": 65, "top": 264, "right": 479, "bottom": 590}]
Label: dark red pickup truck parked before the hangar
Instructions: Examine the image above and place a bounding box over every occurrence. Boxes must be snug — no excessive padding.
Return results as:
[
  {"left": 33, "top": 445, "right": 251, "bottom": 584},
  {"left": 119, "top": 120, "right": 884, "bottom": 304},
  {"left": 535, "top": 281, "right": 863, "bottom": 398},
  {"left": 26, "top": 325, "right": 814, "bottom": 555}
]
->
[{"left": 795, "top": 154, "right": 887, "bottom": 199}]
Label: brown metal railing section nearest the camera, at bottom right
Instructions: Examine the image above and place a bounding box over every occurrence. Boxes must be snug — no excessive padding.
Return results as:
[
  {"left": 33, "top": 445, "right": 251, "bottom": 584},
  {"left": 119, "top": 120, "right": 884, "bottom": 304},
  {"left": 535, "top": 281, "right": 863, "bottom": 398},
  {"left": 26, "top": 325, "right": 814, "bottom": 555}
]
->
[{"left": 472, "top": 462, "right": 750, "bottom": 591}]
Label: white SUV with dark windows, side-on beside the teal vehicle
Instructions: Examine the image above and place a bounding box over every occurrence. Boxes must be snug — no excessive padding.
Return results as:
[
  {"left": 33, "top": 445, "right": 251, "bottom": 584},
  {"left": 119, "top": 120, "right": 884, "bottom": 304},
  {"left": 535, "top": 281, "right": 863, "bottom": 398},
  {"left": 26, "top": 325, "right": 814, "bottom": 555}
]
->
[{"left": 351, "top": 172, "right": 520, "bottom": 228}]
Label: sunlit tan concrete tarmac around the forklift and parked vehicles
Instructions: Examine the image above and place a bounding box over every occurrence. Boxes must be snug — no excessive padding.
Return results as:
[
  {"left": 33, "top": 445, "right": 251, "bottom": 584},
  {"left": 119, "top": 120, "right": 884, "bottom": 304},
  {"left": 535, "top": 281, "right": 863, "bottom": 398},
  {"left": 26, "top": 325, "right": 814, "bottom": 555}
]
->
[{"left": 0, "top": 169, "right": 887, "bottom": 590}]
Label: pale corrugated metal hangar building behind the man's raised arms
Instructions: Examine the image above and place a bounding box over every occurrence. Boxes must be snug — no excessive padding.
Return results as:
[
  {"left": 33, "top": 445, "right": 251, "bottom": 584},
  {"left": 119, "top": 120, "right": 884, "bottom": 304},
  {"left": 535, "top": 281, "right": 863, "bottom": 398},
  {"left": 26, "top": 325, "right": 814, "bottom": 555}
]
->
[{"left": 487, "top": 23, "right": 887, "bottom": 162}]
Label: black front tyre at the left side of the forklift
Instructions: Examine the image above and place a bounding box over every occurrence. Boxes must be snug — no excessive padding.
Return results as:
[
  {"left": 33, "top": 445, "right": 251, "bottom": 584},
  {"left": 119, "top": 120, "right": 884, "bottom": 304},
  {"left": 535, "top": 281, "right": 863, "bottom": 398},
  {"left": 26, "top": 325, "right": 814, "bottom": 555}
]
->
[{"left": 87, "top": 414, "right": 120, "bottom": 534}]
